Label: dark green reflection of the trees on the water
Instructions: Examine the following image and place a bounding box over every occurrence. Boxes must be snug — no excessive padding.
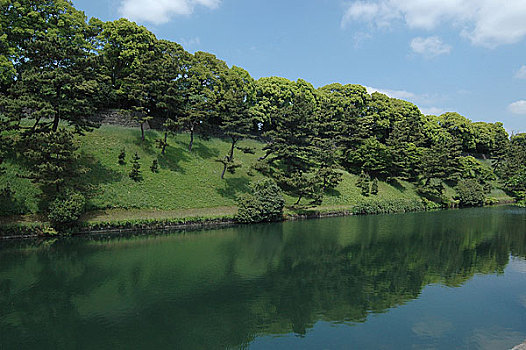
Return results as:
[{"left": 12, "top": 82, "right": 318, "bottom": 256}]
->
[{"left": 0, "top": 206, "right": 526, "bottom": 349}]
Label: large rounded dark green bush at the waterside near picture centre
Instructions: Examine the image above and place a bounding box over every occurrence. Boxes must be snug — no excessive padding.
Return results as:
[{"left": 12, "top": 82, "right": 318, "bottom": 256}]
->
[{"left": 236, "top": 179, "right": 285, "bottom": 223}]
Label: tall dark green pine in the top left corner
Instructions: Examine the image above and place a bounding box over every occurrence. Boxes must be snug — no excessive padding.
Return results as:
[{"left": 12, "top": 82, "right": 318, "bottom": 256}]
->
[{"left": 0, "top": 0, "right": 100, "bottom": 133}]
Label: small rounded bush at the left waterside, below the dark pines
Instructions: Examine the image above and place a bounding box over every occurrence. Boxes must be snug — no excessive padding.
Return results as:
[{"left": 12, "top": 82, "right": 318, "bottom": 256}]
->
[{"left": 48, "top": 191, "right": 86, "bottom": 231}]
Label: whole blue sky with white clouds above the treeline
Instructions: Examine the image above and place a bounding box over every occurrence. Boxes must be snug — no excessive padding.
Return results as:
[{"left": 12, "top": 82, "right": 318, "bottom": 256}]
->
[{"left": 73, "top": 0, "right": 526, "bottom": 132}]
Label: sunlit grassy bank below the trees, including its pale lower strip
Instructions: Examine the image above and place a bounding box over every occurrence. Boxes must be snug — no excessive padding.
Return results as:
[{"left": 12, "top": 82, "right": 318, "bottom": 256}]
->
[{"left": 0, "top": 126, "right": 510, "bottom": 237}]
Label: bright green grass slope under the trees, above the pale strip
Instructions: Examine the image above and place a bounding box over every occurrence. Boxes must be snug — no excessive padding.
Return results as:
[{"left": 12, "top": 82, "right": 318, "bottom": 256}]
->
[{"left": 0, "top": 126, "right": 503, "bottom": 220}]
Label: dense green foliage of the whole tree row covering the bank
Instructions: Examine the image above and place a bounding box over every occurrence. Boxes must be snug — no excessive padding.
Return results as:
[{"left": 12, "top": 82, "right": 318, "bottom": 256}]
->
[{"left": 0, "top": 0, "right": 526, "bottom": 227}]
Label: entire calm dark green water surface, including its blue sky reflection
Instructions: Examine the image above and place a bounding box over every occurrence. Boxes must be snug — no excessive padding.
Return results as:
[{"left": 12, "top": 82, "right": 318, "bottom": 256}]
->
[{"left": 0, "top": 207, "right": 526, "bottom": 349}]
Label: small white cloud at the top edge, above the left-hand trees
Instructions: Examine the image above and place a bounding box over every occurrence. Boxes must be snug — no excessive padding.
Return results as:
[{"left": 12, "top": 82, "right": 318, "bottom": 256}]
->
[{"left": 119, "top": 0, "right": 221, "bottom": 24}]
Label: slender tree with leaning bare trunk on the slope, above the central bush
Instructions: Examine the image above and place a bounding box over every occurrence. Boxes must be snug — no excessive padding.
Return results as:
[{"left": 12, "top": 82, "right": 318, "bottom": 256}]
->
[{"left": 219, "top": 66, "right": 255, "bottom": 179}]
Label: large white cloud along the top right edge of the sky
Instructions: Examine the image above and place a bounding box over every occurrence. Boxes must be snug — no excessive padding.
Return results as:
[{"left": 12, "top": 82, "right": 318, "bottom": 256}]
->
[{"left": 342, "top": 0, "right": 526, "bottom": 48}]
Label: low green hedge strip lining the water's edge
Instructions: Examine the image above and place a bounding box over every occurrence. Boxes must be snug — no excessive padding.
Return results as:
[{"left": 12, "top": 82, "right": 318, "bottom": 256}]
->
[{"left": 0, "top": 200, "right": 513, "bottom": 241}]
